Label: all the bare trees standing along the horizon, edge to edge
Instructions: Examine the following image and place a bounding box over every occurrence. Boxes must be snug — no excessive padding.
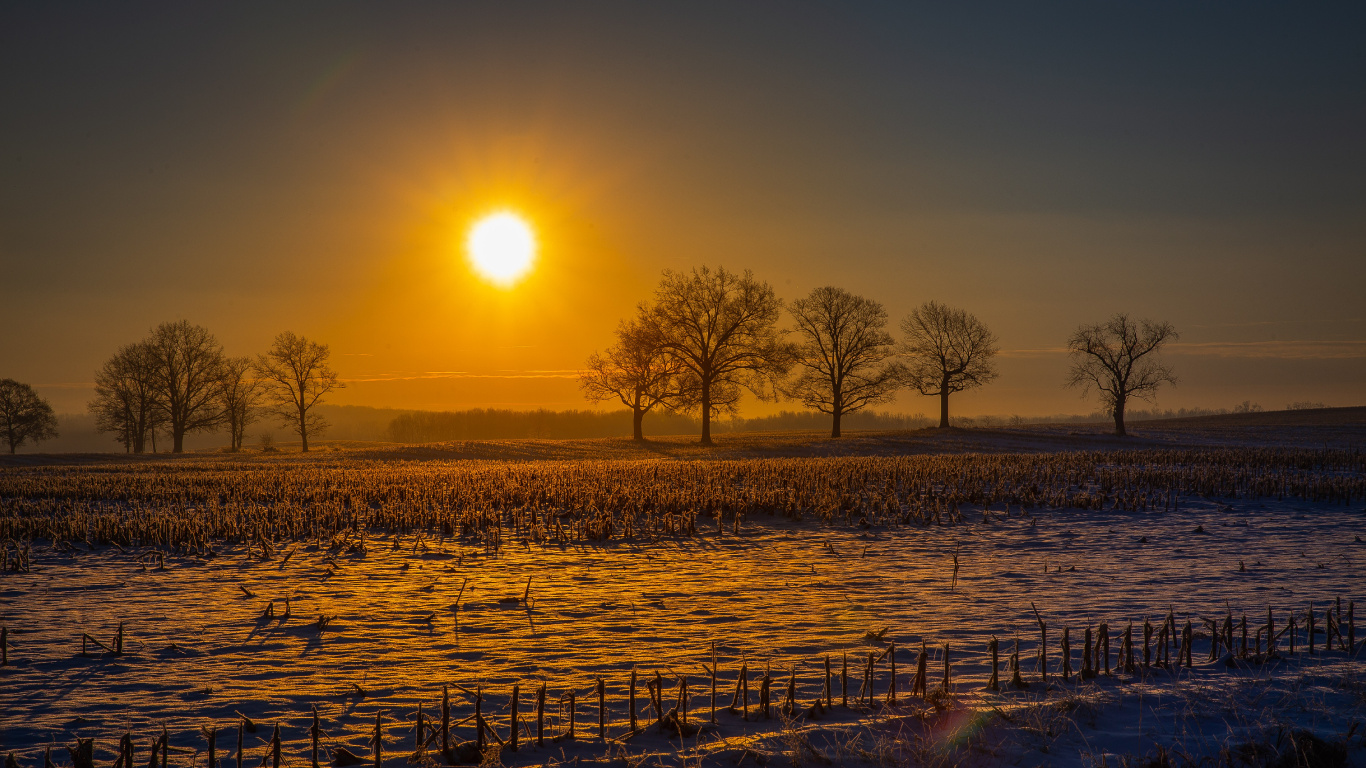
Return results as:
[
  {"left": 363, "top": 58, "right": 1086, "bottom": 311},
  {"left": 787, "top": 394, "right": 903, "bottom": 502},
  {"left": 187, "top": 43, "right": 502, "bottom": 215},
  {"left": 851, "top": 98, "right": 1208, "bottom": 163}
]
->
[{"left": 0, "top": 266, "right": 1177, "bottom": 454}]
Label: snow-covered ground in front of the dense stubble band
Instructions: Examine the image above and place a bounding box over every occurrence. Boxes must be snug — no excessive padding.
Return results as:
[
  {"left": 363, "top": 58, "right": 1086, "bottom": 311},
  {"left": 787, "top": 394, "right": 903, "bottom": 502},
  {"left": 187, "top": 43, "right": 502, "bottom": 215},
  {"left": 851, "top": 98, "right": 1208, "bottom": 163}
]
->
[{"left": 0, "top": 499, "right": 1366, "bottom": 767}]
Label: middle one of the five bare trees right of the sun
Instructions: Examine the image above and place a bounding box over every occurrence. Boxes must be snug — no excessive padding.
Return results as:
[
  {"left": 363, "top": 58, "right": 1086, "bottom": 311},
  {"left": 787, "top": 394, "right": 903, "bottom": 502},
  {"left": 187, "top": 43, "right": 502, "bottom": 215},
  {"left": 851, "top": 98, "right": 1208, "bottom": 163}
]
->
[{"left": 785, "top": 286, "right": 904, "bottom": 437}]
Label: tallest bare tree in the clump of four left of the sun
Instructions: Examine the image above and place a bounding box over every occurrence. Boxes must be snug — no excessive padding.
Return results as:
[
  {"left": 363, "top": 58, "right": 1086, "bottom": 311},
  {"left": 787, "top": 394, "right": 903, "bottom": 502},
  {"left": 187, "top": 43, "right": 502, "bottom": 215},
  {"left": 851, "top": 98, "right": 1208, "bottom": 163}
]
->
[{"left": 145, "top": 320, "right": 225, "bottom": 454}]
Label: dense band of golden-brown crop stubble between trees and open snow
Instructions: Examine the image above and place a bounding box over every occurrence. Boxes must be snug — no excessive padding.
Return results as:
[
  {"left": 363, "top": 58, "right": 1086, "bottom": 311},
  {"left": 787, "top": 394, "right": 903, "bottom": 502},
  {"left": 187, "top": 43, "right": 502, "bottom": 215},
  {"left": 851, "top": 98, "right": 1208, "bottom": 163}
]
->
[{"left": 0, "top": 448, "right": 1366, "bottom": 549}]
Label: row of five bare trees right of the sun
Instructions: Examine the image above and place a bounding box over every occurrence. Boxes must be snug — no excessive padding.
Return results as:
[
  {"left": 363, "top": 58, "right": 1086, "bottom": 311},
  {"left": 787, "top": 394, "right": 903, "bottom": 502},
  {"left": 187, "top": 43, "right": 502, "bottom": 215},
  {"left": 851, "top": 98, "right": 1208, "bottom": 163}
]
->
[{"left": 579, "top": 266, "right": 1177, "bottom": 444}]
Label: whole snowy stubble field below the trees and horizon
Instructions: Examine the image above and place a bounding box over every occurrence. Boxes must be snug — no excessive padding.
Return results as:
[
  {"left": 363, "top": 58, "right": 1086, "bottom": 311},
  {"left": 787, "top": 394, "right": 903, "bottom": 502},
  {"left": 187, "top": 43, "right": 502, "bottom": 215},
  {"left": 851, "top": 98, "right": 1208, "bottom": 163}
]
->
[{"left": 0, "top": 409, "right": 1366, "bottom": 767}]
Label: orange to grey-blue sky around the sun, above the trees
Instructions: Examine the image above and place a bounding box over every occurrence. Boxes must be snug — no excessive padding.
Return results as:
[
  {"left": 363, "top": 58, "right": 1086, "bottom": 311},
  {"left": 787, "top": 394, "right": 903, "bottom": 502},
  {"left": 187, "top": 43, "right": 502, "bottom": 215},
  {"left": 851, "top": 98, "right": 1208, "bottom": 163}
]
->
[{"left": 0, "top": 3, "right": 1366, "bottom": 415}]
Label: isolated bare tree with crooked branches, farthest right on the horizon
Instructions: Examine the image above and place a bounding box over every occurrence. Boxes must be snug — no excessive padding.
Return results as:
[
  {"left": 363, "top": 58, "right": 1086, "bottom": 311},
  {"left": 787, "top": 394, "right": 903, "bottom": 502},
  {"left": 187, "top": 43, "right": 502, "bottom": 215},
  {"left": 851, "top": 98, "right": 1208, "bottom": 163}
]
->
[{"left": 1067, "top": 307, "right": 1180, "bottom": 437}]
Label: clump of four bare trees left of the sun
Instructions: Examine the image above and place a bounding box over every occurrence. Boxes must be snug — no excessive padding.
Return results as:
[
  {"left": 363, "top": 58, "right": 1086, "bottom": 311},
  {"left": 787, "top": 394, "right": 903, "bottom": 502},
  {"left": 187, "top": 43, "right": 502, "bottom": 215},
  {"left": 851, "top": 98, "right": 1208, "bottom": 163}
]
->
[{"left": 89, "top": 320, "right": 346, "bottom": 454}]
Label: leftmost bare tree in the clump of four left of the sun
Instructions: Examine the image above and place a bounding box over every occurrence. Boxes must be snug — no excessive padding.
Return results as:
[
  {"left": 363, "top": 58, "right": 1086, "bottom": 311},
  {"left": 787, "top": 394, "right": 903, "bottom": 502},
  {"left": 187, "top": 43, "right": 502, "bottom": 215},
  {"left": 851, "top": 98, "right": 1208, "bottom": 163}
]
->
[{"left": 87, "top": 342, "right": 161, "bottom": 454}]
